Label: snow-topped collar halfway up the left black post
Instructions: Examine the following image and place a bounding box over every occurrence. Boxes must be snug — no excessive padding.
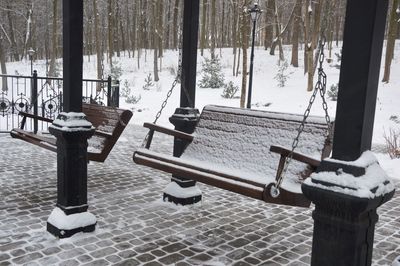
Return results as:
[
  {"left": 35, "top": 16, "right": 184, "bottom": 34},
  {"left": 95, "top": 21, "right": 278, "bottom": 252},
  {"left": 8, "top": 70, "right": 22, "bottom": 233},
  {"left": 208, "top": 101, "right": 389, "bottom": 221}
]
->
[{"left": 49, "top": 112, "right": 94, "bottom": 132}]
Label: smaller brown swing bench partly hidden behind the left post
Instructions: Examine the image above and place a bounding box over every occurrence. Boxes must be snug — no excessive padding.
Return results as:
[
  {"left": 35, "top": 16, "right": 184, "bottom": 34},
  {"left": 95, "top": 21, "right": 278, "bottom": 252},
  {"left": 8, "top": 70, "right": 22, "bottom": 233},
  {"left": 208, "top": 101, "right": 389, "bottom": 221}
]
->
[{"left": 10, "top": 104, "right": 132, "bottom": 162}]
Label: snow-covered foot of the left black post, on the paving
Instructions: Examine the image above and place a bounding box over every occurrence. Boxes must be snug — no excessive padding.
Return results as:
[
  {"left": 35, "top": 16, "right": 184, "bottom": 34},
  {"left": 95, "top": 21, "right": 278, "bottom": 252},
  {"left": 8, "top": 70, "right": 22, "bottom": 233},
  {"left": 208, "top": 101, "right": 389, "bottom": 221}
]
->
[{"left": 47, "top": 207, "right": 97, "bottom": 237}]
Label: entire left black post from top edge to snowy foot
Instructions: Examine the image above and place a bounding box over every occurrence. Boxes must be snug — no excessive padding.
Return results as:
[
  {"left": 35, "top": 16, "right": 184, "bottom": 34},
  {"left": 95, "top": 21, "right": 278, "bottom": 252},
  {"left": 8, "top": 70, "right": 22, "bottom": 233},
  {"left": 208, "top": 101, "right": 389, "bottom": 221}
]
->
[{"left": 47, "top": 0, "right": 96, "bottom": 238}]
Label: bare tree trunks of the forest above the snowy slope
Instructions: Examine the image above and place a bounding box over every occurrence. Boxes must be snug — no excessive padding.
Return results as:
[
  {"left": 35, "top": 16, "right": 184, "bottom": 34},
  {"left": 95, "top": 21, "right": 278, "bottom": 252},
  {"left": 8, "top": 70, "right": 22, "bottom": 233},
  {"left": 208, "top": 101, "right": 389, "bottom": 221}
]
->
[{"left": 0, "top": 0, "right": 400, "bottom": 97}]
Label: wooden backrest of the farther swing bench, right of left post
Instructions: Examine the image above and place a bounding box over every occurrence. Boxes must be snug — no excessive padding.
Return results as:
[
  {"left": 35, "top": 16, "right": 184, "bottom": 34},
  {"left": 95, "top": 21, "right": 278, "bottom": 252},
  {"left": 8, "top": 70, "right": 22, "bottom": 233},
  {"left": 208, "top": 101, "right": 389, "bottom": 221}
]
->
[{"left": 82, "top": 104, "right": 132, "bottom": 162}]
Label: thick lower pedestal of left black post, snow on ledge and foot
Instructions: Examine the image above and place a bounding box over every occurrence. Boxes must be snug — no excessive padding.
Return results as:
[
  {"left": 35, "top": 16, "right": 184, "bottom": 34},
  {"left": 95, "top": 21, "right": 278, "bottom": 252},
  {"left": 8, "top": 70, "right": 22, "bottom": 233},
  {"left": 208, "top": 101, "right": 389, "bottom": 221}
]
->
[{"left": 47, "top": 112, "right": 96, "bottom": 238}]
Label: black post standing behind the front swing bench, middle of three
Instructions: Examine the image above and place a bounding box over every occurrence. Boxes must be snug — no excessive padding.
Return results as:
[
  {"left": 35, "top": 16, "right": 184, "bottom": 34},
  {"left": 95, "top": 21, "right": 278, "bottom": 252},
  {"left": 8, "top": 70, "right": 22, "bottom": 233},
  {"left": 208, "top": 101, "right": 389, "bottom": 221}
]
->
[{"left": 163, "top": 0, "right": 201, "bottom": 205}]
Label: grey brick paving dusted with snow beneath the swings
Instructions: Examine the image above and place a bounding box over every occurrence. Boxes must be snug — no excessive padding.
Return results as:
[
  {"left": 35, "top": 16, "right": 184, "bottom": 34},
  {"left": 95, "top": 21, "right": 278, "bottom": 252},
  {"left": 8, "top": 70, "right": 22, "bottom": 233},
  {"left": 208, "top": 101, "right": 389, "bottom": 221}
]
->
[{"left": 0, "top": 125, "right": 400, "bottom": 266}]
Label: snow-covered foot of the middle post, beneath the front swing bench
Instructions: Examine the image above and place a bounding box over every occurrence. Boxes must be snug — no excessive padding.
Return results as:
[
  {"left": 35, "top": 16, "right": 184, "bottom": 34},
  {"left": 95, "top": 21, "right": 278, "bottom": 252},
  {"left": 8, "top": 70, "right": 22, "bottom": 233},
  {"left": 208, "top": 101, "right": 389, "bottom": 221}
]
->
[{"left": 163, "top": 181, "right": 202, "bottom": 205}]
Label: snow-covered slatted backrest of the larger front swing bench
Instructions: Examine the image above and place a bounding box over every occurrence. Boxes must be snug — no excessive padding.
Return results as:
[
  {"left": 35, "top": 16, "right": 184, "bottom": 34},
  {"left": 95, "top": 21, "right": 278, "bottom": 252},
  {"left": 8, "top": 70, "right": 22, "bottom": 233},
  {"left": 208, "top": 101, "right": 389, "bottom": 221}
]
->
[{"left": 181, "top": 105, "right": 330, "bottom": 186}]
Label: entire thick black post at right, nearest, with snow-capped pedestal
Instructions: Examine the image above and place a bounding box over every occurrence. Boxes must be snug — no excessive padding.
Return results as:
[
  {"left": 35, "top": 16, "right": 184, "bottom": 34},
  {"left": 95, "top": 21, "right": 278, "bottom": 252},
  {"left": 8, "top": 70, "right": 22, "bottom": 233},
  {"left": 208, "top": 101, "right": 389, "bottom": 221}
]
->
[{"left": 302, "top": 0, "right": 394, "bottom": 266}]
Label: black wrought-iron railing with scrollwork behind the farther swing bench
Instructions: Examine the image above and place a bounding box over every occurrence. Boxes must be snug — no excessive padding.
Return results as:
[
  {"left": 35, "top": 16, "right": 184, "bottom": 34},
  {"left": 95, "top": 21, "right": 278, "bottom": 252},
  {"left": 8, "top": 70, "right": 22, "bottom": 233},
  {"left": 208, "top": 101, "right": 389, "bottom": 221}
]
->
[{"left": 0, "top": 70, "right": 119, "bottom": 133}]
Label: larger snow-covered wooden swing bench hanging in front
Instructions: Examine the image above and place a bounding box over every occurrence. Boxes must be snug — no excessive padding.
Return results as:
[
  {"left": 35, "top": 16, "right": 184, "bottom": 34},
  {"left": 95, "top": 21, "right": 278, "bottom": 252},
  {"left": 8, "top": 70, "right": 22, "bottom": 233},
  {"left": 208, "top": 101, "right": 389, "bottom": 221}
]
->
[{"left": 133, "top": 106, "right": 331, "bottom": 207}]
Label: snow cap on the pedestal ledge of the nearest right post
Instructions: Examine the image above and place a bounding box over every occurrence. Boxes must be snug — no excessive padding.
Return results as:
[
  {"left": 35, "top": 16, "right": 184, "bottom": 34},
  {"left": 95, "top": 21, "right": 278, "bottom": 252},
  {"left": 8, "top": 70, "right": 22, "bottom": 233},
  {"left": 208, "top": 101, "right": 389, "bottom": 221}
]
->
[{"left": 304, "top": 151, "right": 395, "bottom": 199}]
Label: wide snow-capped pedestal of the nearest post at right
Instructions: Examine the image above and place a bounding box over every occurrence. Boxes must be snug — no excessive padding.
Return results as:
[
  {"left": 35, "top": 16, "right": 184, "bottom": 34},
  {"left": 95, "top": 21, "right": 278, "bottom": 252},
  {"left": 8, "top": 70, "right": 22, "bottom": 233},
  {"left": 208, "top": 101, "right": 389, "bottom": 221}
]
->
[{"left": 302, "top": 152, "right": 395, "bottom": 266}]
